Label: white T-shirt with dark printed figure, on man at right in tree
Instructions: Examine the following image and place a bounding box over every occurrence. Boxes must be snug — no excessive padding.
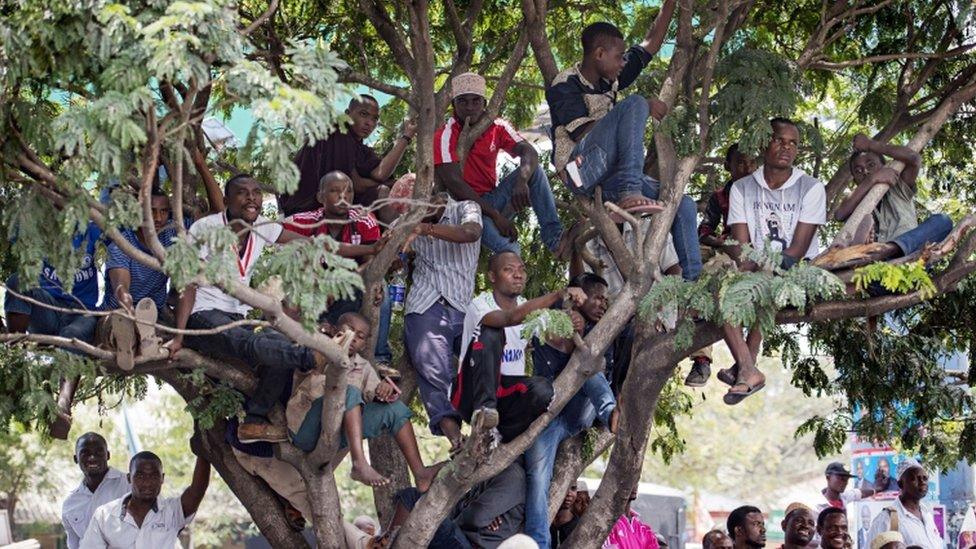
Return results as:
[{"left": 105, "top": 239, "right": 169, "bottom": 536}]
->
[{"left": 729, "top": 167, "right": 827, "bottom": 259}]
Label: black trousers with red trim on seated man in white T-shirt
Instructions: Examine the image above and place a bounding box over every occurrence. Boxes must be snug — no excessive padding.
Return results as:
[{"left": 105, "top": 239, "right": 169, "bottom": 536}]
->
[{"left": 451, "top": 326, "right": 553, "bottom": 442}]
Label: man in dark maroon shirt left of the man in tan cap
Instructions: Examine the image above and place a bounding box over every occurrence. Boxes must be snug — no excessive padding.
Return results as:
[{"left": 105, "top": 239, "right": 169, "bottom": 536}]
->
[{"left": 278, "top": 95, "right": 417, "bottom": 216}]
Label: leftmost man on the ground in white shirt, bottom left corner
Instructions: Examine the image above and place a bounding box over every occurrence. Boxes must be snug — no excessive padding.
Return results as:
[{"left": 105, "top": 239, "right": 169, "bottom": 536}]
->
[{"left": 61, "top": 432, "right": 129, "bottom": 549}]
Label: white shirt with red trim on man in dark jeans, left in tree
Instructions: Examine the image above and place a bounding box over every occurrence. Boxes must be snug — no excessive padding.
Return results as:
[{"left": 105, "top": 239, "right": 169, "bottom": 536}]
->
[{"left": 190, "top": 212, "right": 283, "bottom": 315}]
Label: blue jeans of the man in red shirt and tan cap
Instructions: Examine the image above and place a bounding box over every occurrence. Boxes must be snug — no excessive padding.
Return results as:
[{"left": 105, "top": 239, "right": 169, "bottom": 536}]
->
[{"left": 481, "top": 166, "right": 563, "bottom": 253}]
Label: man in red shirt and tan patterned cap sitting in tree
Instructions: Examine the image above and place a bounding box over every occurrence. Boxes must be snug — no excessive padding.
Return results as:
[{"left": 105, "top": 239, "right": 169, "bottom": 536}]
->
[{"left": 434, "top": 72, "right": 570, "bottom": 256}]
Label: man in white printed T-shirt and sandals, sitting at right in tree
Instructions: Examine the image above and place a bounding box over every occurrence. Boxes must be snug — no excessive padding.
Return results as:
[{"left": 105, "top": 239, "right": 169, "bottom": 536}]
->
[{"left": 718, "top": 118, "right": 827, "bottom": 405}]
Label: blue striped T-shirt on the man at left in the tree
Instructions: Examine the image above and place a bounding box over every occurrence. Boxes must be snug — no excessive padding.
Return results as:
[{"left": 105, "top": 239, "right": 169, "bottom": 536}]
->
[{"left": 102, "top": 223, "right": 184, "bottom": 309}]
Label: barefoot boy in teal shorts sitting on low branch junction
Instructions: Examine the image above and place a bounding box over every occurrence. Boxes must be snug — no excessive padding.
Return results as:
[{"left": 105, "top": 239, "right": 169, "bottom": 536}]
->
[{"left": 286, "top": 313, "right": 437, "bottom": 492}]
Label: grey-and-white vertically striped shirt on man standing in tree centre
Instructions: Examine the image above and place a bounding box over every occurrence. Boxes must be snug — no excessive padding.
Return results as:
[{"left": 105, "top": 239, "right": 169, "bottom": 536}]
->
[{"left": 406, "top": 199, "right": 481, "bottom": 314}]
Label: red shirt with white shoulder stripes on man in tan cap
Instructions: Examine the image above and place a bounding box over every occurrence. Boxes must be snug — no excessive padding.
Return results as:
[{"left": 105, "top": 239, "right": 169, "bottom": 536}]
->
[{"left": 434, "top": 116, "right": 523, "bottom": 196}]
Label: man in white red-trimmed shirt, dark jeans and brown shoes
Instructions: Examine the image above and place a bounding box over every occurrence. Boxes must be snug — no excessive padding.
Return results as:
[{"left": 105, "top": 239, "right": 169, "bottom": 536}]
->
[{"left": 167, "top": 174, "right": 325, "bottom": 443}]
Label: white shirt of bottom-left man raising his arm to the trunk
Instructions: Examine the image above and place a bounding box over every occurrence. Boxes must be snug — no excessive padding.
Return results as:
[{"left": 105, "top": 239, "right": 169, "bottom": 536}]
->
[{"left": 81, "top": 494, "right": 193, "bottom": 549}]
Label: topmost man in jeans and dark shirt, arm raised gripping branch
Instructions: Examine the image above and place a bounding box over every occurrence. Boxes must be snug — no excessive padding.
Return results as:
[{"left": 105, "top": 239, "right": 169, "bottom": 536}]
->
[{"left": 546, "top": 0, "right": 701, "bottom": 280}]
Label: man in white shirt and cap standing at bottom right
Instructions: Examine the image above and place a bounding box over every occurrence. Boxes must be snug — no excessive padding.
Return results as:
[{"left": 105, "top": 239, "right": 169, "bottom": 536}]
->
[{"left": 868, "top": 458, "right": 945, "bottom": 549}]
